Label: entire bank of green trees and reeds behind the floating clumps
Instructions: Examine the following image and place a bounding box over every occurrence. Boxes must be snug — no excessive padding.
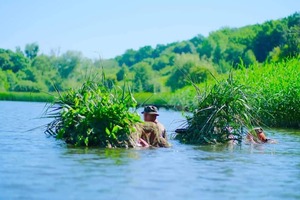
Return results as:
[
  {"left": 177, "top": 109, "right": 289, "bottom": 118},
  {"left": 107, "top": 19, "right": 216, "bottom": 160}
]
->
[{"left": 0, "top": 13, "right": 300, "bottom": 128}]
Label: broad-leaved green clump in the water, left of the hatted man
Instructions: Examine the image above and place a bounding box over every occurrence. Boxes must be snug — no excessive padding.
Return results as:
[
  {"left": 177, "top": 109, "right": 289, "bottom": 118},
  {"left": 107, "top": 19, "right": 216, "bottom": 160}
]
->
[{"left": 46, "top": 81, "right": 140, "bottom": 147}]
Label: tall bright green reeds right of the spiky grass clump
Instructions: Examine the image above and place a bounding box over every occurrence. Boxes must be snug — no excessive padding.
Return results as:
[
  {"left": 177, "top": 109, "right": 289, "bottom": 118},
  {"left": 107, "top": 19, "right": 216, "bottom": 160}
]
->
[{"left": 236, "top": 57, "right": 300, "bottom": 128}]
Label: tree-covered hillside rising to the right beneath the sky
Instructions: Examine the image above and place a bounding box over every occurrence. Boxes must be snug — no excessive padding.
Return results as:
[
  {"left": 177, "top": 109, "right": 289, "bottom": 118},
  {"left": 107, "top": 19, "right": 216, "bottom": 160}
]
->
[{"left": 0, "top": 13, "right": 300, "bottom": 93}]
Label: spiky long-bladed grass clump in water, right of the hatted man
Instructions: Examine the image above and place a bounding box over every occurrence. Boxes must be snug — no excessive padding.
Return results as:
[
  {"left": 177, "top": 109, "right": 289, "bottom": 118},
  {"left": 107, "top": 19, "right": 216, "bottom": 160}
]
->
[{"left": 176, "top": 74, "right": 256, "bottom": 144}]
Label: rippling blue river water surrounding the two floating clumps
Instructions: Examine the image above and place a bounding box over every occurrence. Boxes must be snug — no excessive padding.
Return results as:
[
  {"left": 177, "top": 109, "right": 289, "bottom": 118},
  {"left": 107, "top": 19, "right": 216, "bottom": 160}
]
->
[{"left": 0, "top": 101, "right": 300, "bottom": 199}]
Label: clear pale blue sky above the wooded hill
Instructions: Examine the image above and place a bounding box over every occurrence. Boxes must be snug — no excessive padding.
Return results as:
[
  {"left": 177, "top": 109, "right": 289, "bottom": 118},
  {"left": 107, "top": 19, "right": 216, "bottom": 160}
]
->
[{"left": 0, "top": 0, "right": 300, "bottom": 58}]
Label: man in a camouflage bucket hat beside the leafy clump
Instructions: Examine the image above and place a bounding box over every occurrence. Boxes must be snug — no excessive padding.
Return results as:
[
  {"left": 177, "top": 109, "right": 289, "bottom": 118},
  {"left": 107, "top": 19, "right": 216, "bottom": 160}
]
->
[{"left": 142, "top": 106, "right": 167, "bottom": 140}]
